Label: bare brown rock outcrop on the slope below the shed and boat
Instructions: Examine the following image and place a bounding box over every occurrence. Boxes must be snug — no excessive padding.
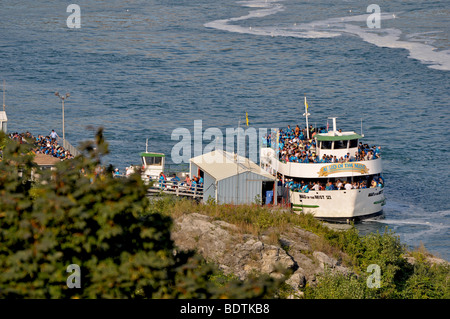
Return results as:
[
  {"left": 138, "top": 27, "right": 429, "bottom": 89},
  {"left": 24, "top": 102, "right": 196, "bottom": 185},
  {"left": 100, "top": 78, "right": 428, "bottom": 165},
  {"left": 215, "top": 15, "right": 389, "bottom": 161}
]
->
[{"left": 172, "top": 213, "right": 350, "bottom": 291}]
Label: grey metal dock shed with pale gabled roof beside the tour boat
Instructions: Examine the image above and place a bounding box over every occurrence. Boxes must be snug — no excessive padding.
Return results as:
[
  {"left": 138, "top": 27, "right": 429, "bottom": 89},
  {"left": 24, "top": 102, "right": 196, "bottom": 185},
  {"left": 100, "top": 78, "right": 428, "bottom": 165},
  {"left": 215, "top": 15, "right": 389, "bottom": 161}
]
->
[{"left": 189, "top": 150, "right": 275, "bottom": 204}]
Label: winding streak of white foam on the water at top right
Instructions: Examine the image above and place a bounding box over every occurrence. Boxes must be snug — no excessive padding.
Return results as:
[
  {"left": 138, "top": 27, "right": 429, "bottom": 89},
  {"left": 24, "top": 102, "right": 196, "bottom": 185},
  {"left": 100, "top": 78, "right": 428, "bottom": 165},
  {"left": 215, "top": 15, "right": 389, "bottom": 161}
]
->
[{"left": 204, "top": 0, "right": 450, "bottom": 71}]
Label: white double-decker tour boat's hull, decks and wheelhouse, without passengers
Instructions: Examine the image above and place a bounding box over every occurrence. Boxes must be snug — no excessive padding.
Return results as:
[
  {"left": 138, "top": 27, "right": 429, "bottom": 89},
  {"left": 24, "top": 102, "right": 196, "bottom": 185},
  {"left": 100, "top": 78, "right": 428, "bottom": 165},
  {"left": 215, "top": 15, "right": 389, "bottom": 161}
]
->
[{"left": 260, "top": 116, "right": 386, "bottom": 223}]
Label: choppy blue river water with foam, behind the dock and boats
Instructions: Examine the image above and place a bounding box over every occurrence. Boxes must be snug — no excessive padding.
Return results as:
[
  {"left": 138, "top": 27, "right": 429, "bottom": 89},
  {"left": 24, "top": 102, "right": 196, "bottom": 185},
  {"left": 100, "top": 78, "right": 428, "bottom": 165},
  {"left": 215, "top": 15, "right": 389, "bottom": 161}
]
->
[{"left": 0, "top": 0, "right": 450, "bottom": 260}]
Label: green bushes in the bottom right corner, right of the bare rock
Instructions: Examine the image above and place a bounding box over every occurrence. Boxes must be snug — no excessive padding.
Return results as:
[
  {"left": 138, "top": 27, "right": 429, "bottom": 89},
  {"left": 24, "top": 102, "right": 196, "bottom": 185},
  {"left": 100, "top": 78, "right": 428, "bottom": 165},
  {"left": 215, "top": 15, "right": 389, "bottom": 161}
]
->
[{"left": 304, "top": 228, "right": 450, "bottom": 299}]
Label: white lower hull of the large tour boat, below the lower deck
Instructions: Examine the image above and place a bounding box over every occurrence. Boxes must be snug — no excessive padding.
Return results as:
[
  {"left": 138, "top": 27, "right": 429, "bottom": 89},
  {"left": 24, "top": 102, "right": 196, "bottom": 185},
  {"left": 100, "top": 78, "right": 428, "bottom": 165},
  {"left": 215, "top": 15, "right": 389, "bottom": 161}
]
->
[{"left": 290, "top": 187, "right": 386, "bottom": 222}]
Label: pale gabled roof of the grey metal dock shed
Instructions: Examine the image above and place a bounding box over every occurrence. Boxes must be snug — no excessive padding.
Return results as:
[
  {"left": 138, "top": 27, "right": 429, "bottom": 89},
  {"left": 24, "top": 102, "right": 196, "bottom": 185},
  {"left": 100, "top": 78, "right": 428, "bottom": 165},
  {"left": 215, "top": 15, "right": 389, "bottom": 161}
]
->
[{"left": 190, "top": 150, "right": 275, "bottom": 181}]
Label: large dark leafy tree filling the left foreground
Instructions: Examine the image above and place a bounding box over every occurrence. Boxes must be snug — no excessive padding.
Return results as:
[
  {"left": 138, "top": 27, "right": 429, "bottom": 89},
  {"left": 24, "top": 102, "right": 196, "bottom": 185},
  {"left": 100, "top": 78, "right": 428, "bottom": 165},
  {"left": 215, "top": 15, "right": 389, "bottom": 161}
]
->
[{"left": 0, "top": 130, "right": 279, "bottom": 298}]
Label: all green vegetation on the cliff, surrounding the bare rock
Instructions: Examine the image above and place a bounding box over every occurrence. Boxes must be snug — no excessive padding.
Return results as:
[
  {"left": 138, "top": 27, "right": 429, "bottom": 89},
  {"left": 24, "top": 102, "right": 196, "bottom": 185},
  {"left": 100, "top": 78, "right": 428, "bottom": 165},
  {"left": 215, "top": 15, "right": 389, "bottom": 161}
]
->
[{"left": 0, "top": 130, "right": 450, "bottom": 298}]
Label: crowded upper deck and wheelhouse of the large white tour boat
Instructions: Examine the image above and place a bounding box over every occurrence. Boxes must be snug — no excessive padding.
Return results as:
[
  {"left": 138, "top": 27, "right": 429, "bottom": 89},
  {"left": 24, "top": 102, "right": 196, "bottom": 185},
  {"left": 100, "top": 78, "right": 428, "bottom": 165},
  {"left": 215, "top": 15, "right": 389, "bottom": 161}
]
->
[{"left": 260, "top": 118, "right": 382, "bottom": 178}]
